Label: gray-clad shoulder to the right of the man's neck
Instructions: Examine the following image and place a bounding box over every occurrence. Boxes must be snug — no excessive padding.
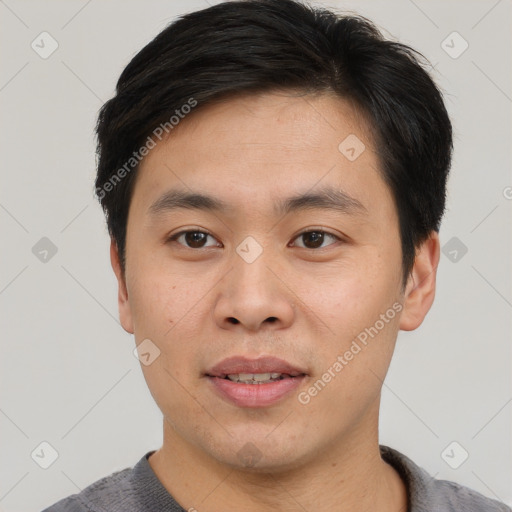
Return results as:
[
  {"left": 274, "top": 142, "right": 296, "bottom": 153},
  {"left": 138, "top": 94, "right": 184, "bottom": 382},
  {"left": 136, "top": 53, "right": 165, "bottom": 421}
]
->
[{"left": 380, "top": 445, "right": 512, "bottom": 512}]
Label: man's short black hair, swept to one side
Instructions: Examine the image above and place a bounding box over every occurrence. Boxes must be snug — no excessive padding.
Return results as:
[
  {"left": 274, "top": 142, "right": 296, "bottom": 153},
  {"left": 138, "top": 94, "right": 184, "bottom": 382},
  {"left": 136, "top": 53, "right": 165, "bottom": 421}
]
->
[{"left": 95, "top": 0, "right": 452, "bottom": 287}]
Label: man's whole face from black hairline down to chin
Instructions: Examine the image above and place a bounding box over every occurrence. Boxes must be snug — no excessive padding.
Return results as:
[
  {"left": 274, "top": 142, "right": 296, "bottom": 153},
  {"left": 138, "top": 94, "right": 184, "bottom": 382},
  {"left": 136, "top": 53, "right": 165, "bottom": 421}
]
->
[{"left": 115, "top": 94, "right": 412, "bottom": 470}]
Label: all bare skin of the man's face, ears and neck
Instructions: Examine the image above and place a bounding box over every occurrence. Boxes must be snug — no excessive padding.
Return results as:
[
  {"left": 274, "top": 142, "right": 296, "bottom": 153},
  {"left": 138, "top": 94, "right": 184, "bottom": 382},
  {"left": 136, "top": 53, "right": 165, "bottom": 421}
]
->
[{"left": 111, "top": 92, "right": 439, "bottom": 512}]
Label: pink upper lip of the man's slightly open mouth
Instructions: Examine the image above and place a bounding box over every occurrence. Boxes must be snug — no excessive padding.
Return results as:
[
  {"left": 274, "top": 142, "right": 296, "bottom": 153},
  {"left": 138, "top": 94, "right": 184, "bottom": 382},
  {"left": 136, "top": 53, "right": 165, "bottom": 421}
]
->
[{"left": 206, "top": 356, "right": 306, "bottom": 377}]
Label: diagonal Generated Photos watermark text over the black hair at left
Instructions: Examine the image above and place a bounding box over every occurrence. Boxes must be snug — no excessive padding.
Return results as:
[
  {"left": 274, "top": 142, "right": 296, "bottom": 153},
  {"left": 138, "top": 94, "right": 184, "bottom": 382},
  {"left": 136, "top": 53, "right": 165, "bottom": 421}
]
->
[{"left": 96, "top": 98, "right": 197, "bottom": 201}]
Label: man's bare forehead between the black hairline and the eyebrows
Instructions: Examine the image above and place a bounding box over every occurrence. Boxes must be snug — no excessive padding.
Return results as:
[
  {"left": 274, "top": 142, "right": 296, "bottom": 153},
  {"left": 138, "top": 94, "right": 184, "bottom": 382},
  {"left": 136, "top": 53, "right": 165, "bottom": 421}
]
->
[{"left": 134, "top": 93, "right": 391, "bottom": 222}]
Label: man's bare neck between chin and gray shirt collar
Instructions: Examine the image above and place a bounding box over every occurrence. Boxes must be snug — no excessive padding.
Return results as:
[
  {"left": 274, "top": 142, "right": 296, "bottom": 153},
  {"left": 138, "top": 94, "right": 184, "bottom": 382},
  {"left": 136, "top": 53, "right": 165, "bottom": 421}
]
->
[{"left": 149, "top": 412, "right": 407, "bottom": 512}]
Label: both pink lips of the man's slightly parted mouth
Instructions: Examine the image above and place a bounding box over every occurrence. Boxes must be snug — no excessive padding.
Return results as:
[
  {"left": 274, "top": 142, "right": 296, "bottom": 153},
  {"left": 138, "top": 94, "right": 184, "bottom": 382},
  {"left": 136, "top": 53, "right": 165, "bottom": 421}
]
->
[{"left": 205, "top": 356, "right": 307, "bottom": 408}]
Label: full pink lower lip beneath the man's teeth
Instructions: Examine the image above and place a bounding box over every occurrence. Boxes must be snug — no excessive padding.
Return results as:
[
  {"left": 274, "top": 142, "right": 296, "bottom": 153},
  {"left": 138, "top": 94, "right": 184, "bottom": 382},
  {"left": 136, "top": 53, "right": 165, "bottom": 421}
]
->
[{"left": 208, "top": 375, "right": 305, "bottom": 407}]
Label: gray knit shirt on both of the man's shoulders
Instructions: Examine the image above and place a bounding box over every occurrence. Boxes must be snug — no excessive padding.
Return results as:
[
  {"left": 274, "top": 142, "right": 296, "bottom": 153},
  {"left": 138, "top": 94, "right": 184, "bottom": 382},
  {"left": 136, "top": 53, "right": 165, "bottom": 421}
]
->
[{"left": 43, "top": 445, "right": 512, "bottom": 512}]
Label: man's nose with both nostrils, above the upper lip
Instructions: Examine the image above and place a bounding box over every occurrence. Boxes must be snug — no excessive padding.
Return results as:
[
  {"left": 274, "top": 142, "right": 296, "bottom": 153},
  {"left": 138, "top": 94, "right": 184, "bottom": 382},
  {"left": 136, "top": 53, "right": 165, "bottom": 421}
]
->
[{"left": 213, "top": 244, "right": 295, "bottom": 332}]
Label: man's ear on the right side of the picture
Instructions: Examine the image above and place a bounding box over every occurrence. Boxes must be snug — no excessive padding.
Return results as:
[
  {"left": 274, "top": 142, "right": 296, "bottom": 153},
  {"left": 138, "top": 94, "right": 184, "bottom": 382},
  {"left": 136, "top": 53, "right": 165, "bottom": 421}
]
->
[{"left": 400, "top": 231, "right": 440, "bottom": 331}]
